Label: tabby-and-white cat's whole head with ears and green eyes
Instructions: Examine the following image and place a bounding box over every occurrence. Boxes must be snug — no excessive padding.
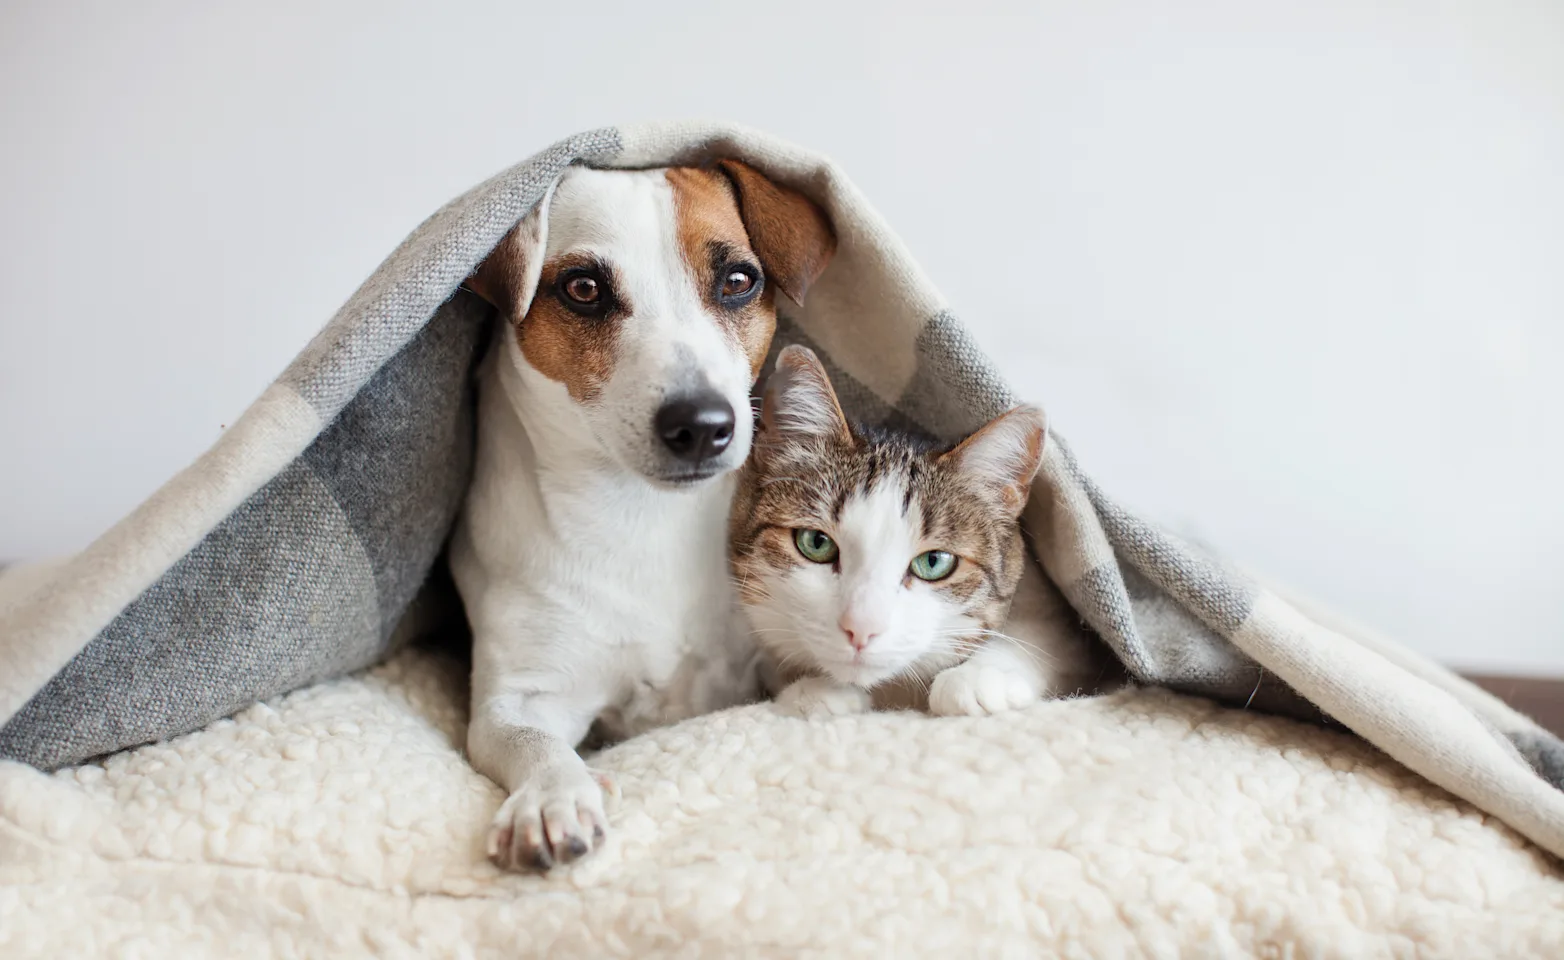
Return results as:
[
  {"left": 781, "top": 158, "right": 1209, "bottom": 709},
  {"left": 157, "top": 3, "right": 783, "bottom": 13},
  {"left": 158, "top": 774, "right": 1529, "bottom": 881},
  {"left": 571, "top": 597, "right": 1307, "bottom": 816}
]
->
[{"left": 730, "top": 346, "right": 1045, "bottom": 685}]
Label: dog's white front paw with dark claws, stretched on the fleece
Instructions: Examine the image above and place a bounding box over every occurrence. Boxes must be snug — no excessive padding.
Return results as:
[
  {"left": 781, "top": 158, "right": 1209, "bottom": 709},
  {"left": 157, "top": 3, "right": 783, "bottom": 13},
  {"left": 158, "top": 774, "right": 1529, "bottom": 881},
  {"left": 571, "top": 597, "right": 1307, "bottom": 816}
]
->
[{"left": 488, "top": 761, "right": 613, "bottom": 871}]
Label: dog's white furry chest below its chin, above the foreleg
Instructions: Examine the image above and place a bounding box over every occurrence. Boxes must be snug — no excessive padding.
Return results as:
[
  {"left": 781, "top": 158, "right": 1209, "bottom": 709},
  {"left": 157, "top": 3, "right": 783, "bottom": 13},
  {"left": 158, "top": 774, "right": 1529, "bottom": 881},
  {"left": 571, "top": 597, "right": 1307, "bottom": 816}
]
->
[{"left": 452, "top": 409, "right": 755, "bottom": 738}]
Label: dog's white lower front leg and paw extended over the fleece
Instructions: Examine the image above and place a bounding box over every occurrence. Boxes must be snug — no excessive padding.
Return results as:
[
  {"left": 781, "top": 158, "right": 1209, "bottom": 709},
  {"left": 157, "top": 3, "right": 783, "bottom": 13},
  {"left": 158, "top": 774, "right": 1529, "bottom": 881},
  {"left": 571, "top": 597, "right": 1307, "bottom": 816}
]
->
[{"left": 468, "top": 693, "right": 608, "bottom": 869}]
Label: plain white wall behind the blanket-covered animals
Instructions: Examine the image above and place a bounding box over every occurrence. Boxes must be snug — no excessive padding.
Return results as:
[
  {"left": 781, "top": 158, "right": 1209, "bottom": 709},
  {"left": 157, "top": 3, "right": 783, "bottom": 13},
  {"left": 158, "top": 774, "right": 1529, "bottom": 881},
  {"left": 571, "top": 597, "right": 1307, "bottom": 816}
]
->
[{"left": 0, "top": 0, "right": 1564, "bottom": 672}]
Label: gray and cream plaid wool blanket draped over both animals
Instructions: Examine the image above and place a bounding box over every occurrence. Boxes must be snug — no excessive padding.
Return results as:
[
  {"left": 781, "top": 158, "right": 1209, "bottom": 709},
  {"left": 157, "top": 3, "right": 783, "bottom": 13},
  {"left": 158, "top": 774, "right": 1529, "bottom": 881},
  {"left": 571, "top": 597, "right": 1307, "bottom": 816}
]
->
[{"left": 0, "top": 124, "right": 1564, "bottom": 855}]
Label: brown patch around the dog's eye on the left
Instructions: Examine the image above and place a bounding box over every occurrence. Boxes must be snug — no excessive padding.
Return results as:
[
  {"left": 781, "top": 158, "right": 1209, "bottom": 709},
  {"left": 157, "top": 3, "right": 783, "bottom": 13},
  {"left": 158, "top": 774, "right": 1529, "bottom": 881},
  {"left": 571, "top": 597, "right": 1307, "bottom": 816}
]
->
[{"left": 516, "top": 253, "right": 633, "bottom": 403}]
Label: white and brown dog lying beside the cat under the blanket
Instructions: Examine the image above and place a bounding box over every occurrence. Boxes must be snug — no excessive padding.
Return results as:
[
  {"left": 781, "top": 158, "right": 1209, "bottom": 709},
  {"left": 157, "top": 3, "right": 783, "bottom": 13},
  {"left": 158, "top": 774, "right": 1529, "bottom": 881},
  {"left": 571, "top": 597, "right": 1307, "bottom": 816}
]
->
[{"left": 450, "top": 161, "right": 835, "bottom": 871}]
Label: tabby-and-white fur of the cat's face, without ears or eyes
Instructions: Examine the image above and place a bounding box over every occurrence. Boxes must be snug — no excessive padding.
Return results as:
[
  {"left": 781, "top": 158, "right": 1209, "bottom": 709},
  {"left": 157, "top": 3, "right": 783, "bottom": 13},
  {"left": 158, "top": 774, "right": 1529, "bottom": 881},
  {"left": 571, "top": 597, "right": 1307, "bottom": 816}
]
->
[{"left": 730, "top": 412, "right": 1026, "bottom": 682}]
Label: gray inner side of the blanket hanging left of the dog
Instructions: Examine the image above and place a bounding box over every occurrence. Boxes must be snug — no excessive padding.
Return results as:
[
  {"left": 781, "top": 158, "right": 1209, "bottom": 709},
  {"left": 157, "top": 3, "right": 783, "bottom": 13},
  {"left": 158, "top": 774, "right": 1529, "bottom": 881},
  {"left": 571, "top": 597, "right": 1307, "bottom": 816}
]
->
[{"left": 0, "top": 304, "right": 491, "bottom": 769}]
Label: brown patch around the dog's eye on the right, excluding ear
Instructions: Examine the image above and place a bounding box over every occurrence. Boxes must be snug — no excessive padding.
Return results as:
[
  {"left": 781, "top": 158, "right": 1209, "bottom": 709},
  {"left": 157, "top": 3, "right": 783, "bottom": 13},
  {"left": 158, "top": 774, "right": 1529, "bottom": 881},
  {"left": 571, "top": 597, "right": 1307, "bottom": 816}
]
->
[{"left": 668, "top": 167, "right": 777, "bottom": 377}]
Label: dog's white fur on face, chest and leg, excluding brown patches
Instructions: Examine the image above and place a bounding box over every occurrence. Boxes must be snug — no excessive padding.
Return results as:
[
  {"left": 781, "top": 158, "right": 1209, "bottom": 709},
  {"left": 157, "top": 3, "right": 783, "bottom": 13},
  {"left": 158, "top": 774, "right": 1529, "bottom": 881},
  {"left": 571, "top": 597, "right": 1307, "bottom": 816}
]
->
[{"left": 450, "top": 169, "right": 766, "bottom": 865}]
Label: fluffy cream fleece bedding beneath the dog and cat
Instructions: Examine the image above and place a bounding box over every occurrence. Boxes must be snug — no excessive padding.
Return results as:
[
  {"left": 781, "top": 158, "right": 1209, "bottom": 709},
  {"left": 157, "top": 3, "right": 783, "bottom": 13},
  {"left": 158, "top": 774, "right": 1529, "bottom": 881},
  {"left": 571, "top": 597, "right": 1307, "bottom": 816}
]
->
[{"left": 0, "top": 650, "right": 1564, "bottom": 958}]
